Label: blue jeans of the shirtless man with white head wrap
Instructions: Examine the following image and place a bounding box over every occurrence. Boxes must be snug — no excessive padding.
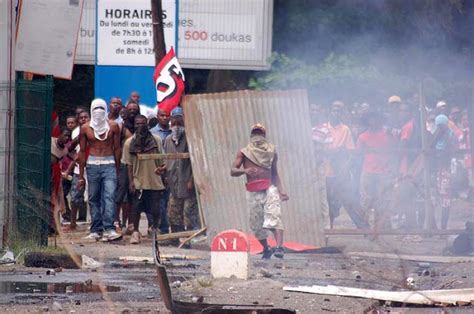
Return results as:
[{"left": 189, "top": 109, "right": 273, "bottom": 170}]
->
[{"left": 87, "top": 164, "right": 117, "bottom": 233}]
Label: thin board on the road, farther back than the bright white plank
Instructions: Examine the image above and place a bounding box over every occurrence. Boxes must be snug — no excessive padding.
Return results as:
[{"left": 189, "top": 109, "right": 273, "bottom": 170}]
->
[{"left": 345, "top": 252, "right": 474, "bottom": 264}]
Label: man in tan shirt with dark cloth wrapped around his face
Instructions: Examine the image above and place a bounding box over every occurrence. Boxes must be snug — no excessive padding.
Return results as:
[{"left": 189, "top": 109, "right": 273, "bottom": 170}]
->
[{"left": 123, "top": 115, "right": 166, "bottom": 244}]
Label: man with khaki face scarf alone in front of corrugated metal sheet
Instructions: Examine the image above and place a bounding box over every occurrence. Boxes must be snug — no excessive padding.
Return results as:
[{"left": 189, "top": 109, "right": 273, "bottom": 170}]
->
[{"left": 230, "top": 124, "right": 289, "bottom": 259}]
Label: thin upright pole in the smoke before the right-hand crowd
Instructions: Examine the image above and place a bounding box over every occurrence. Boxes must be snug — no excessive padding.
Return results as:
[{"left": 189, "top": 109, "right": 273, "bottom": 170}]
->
[{"left": 418, "top": 81, "right": 436, "bottom": 230}]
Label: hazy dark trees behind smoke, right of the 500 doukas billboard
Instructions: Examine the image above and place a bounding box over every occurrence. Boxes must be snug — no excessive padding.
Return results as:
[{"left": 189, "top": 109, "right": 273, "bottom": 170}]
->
[{"left": 249, "top": 0, "right": 474, "bottom": 106}]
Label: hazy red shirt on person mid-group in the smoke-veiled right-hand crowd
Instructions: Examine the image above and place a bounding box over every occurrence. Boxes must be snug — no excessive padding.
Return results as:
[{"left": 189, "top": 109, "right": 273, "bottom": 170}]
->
[{"left": 357, "top": 129, "right": 392, "bottom": 174}]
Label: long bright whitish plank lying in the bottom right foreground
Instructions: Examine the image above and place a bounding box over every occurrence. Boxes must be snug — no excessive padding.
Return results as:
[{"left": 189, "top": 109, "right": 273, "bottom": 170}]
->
[{"left": 283, "top": 285, "right": 474, "bottom": 305}]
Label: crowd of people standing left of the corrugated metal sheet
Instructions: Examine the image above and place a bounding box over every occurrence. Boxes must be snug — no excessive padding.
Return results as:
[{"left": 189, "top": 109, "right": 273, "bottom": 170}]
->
[{"left": 50, "top": 92, "right": 200, "bottom": 244}]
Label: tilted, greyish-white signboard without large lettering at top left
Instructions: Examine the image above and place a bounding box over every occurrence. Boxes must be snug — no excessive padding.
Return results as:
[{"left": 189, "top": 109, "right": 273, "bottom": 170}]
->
[{"left": 15, "top": 0, "right": 83, "bottom": 79}]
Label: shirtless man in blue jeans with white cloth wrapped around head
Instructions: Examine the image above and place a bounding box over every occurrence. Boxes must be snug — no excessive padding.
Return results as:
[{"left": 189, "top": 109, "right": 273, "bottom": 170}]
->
[{"left": 78, "top": 99, "right": 121, "bottom": 241}]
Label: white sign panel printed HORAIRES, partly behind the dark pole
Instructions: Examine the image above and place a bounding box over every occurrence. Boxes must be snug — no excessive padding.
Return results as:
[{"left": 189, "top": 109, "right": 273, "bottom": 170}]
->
[{"left": 97, "top": 0, "right": 176, "bottom": 66}]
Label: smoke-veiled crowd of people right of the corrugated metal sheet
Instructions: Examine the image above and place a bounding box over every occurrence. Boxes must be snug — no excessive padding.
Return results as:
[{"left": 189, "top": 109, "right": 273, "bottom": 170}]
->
[{"left": 310, "top": 95, "right": 473, "bottom": 229}]
